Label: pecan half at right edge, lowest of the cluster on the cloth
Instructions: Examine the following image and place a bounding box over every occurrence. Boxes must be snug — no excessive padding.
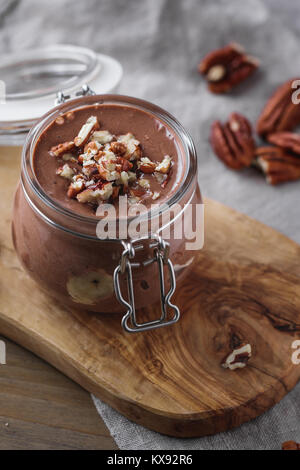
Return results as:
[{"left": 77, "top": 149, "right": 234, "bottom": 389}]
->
[{"left": 256, "top": 147, "right": 300, "bottom": 185}]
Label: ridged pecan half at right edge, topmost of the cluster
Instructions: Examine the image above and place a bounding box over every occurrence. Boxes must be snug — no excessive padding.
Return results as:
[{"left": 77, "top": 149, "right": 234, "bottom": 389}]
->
[{"left": 256, "top": 79, "right": 300, "bottom": 136}]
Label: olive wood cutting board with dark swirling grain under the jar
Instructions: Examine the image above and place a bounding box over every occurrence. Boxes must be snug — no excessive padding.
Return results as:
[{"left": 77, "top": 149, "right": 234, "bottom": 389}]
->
[{"left": 0, "top": 149, "right": 300, "bottom": 437}]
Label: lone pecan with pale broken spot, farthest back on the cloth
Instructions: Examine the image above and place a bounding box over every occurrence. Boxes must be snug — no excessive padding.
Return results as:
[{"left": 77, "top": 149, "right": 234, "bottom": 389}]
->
[{"left": 198, "top": 43, "right": 258, "bottom": 93}]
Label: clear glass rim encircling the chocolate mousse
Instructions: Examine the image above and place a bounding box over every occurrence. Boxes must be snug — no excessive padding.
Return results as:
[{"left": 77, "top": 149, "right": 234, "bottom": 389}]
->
[{"left": 22, "top": 94, "right": 197, "bottom": 240}]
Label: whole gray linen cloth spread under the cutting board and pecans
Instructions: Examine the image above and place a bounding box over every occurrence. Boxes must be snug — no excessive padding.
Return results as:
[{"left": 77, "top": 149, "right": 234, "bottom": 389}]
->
[{"left": 0, "top": 0, "right": 300, "bottom": 449}]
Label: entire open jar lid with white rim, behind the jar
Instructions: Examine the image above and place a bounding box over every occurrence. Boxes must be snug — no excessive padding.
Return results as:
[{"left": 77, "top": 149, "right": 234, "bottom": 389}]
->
[{"left": 0, "top": 44, "right": 123, "bottom": 145}]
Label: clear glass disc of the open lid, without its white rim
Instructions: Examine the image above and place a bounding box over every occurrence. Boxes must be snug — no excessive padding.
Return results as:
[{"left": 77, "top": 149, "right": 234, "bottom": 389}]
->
[{"left": 0, "top": 45, "right": 100, "bottom": 101}]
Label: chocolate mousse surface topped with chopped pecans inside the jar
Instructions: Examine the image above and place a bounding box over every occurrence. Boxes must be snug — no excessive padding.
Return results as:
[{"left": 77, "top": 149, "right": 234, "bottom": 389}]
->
[{"left": 33, "top": 104, "right": 184, "bottom": 216}]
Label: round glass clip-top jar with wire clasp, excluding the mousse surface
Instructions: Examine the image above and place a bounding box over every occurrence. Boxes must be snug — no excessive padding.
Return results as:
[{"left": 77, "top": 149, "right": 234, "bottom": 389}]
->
[{"left": 12, "top": 95, "right": 203, "bottom": 331}]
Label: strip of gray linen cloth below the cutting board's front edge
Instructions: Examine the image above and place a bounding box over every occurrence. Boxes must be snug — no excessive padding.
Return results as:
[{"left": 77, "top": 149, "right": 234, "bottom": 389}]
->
[{"left": 93, "top": 384, "right": 300, "bottom": 450}]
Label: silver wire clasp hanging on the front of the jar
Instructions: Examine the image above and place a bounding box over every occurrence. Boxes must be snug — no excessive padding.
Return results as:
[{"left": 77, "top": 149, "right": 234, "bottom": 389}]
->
[{"left": 114, "top": 236, "right": 180, "bottom": 333}]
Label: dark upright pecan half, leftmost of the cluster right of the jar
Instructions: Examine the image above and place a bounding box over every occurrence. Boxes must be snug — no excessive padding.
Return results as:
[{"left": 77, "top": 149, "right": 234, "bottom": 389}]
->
[{"left": 210, "top": 113, "right": 255, "bottom": 170}]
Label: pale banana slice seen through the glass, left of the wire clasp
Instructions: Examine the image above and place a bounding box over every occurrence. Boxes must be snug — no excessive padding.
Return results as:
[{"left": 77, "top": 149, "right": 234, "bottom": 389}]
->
[{"left": 67, "top": 269, "right": 114, "bottom": 305}]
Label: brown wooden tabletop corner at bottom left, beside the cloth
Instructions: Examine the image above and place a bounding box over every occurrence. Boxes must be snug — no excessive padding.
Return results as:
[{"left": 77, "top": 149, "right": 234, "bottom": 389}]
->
[{"left": 0, "top": 337, "right": 117, "bottom": 450}]
